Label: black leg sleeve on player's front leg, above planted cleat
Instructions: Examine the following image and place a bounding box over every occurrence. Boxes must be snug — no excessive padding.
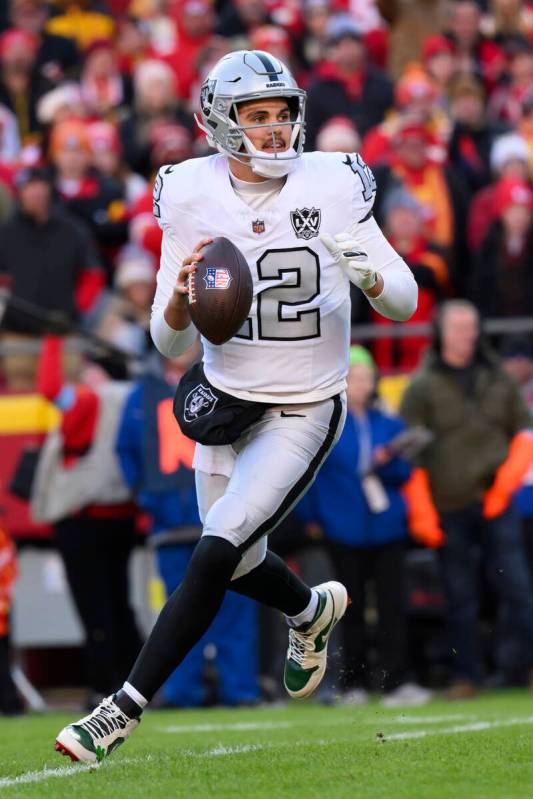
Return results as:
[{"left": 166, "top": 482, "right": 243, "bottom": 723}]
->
[{"left": 123, "top": 536, "right": 241, "bottom": 700}]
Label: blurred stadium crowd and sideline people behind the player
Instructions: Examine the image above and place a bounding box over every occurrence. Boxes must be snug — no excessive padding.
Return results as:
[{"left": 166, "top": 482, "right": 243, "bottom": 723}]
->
[{"left": 0, "top": 0, "right": 533, "bottom": 713}]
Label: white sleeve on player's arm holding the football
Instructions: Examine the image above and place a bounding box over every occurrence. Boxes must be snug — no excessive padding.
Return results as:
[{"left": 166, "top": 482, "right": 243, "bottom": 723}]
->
[{"left": 150, "top": 167, "right": 197, "bottom": 358}]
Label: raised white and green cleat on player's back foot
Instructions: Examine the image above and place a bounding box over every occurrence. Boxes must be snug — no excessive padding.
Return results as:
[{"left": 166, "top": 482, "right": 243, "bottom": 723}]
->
[{"left": 283, "top": 581, "right": 348, "bottom": 699}]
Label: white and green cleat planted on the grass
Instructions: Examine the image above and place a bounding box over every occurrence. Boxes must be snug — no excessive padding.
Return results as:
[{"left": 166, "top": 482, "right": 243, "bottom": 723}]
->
[{"left": 55, "top": 696, "right": 140, "bottom": 763}]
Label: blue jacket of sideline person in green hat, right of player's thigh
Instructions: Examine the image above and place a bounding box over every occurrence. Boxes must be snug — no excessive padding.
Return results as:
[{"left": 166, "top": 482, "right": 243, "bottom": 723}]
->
[{"left": 297, "top": 410, "right": 411, "bottom": 547}]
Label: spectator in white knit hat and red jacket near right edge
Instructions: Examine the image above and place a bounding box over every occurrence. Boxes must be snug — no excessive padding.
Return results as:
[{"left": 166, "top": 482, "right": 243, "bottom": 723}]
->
[{"left": 467, "top": 133, "right": 532, "bottom": 254}]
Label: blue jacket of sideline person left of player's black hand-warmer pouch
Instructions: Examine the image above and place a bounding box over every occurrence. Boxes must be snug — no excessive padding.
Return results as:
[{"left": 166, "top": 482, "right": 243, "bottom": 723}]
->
[{"left": 116, "top": 376, "right": 201, "bottom": 533}]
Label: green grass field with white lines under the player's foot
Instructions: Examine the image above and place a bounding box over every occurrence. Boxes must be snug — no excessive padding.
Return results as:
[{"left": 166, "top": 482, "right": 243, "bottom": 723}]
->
[{"left": 0, "top": 691, "right": 533, "bottom": 799}]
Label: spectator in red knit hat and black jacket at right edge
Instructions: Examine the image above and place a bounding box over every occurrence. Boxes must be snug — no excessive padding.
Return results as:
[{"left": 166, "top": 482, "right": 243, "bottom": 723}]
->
[{"left": 471, "top": 178, "right": 533, "bottom": 316}]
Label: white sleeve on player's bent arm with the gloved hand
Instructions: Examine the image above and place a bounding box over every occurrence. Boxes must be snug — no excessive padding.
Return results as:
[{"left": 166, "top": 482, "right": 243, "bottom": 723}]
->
[{"left": 349, "top": 216, "right": 418, "bottom": 322}]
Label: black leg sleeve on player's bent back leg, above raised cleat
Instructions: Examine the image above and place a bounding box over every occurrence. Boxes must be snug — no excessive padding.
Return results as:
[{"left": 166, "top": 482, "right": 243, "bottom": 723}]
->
[{"left": 229, "top": 550, "right": 311, "bottom": 616}]
